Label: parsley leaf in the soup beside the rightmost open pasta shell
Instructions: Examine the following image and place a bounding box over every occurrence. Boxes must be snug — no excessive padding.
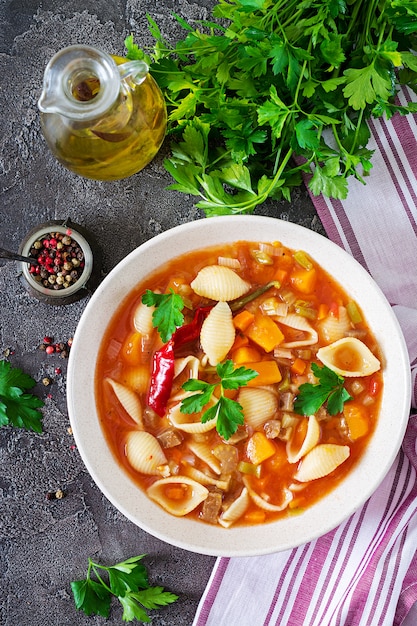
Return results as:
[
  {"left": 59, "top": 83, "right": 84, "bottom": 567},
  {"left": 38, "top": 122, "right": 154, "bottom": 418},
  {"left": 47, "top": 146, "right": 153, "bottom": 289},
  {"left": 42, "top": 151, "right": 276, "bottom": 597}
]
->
[{"left": 294, "top": 363, "right": 352, "bottom": 415}]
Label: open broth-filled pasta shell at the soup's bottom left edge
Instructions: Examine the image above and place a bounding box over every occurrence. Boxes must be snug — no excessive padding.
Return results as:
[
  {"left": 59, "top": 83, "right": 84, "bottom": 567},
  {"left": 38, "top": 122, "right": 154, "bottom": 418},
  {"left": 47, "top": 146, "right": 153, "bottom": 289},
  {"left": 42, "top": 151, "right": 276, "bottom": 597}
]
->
[{"left": 146, "top": 476, "right": 209, "bottom": 517}]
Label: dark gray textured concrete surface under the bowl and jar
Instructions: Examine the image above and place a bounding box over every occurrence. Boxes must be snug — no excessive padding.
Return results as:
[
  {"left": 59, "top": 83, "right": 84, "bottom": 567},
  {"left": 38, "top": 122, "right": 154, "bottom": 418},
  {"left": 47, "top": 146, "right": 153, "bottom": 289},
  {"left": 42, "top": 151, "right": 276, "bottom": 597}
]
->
[{"left": 0, "top": 0, "right": 322, "bottom": 626}]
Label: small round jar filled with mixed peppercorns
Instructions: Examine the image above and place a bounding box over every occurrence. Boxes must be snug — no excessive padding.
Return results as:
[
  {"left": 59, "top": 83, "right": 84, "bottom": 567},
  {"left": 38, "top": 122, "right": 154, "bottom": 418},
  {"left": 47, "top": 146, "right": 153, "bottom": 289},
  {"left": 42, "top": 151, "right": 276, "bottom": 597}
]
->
[{"left": 19, "top": 220, "right": 101, "bottom": 305}]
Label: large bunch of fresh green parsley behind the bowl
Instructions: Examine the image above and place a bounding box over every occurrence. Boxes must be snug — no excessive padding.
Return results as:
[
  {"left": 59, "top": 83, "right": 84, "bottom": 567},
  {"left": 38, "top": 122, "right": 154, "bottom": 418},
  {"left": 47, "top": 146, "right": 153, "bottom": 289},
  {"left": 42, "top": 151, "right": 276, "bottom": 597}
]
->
[{"left": 125, "top": 0, "right": 417, "bottom": 216}]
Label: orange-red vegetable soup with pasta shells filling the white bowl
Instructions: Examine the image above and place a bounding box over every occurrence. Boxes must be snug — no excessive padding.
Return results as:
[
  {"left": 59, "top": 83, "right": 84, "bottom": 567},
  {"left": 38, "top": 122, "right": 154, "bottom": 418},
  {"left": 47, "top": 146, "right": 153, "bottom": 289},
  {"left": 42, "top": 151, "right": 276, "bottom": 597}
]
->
[{"left": 96, "top": 241, "right": 382, "bottom": 528}]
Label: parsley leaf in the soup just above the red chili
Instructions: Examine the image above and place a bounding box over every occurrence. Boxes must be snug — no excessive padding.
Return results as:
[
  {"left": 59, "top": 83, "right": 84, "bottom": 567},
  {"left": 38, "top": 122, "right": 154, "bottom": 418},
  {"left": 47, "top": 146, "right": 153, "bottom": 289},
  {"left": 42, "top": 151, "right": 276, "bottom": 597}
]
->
[{"left": 142, "top": 289, "right": 185, "bottom": 343}]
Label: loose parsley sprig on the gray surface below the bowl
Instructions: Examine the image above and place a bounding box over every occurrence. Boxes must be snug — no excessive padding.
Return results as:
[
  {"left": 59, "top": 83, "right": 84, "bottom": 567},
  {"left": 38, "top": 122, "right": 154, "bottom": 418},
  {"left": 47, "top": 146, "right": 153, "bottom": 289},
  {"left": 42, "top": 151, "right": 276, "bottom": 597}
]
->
[{"left": 71, "top": 554, "right": 178, "bottom": 622}]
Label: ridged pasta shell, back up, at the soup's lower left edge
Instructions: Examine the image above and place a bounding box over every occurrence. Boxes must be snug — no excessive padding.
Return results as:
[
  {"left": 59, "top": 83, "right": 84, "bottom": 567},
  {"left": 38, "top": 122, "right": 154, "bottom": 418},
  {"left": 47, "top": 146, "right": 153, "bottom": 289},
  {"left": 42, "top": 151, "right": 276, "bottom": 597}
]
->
[{"left": 125, "top": 430, "right": 167, "bottom": 476}]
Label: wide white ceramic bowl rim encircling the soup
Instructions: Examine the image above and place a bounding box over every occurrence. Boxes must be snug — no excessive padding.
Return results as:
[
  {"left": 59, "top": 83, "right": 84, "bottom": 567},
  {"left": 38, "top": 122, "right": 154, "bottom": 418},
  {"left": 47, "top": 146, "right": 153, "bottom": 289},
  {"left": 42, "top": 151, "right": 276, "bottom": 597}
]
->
[{"left": 68, "top": 216, "right": 411, "bottom": 556}]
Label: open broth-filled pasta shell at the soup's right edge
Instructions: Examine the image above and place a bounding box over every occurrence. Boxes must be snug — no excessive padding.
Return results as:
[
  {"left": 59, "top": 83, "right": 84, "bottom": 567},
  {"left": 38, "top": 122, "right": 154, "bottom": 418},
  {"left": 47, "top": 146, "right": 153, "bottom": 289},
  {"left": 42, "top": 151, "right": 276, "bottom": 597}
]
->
[{"left": 317, "top": 337, "right": 381, "bottom": 376}]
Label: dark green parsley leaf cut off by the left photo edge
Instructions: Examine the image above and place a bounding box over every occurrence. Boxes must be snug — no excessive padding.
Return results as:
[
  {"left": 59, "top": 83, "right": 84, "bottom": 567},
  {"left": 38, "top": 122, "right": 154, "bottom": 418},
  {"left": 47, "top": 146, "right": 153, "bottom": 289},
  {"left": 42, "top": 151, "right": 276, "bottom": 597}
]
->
[{"left": 0, "top": 361, "right": 44, "bottom": 433}]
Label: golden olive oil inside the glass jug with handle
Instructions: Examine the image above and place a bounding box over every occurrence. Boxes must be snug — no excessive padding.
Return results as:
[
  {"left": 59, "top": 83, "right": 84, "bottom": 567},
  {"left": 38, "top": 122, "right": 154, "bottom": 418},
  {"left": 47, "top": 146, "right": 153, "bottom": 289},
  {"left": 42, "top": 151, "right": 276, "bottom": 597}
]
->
[{"left": 41, "top": 74, "right": 166, "bottom": 180}]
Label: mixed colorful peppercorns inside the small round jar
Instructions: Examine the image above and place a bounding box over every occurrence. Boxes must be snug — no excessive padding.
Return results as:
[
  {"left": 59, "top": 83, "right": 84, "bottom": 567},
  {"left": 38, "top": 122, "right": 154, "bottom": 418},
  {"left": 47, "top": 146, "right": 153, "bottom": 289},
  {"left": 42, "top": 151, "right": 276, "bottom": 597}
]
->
[{"left": 29, "top": 229, "right": 84, "bottom": 288}]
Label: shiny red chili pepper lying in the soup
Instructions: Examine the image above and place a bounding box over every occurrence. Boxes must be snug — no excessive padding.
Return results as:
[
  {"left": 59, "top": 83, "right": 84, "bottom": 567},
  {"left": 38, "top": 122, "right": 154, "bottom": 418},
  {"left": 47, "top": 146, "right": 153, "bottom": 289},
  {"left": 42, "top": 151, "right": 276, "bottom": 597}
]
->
[{"left": 148, "top": 306, "right": 212, "bottom": 417}]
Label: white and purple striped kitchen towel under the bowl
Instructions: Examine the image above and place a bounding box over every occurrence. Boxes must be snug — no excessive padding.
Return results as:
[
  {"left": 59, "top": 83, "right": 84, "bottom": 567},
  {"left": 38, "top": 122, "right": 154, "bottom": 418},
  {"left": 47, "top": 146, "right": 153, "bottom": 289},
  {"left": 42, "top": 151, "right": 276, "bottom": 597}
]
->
[{"left": 193, "top": 91, "right": 417, "bottom": 626}]
